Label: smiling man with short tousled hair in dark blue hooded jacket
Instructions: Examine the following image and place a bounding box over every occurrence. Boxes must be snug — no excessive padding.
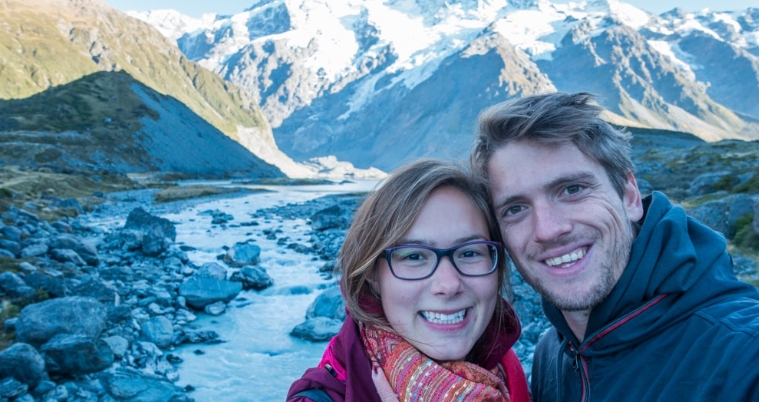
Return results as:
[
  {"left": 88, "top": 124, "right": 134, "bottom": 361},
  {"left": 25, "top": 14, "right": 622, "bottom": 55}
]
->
[{"left": 472, "top": 93, "right": 759, "bottom": 402}]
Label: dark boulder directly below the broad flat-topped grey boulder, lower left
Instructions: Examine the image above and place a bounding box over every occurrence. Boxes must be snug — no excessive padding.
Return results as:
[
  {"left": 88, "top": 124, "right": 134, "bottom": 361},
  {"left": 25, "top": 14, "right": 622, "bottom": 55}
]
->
[{"left": 40, "top": 334, "right": 113, "bottom": 375}]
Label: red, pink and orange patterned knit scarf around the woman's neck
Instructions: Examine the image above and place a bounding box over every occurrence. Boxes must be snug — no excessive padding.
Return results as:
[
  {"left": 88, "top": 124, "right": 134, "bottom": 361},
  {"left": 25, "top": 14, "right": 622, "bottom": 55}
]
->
[{"left": 361, "top": 325, "right": 510, "bottom": 402}]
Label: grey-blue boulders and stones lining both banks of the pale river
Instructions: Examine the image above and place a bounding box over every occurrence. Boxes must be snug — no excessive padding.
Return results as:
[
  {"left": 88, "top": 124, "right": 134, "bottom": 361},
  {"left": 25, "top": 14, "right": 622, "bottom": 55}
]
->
[{"left": 0, "top": 142, "right": 759, "bottom": 402}]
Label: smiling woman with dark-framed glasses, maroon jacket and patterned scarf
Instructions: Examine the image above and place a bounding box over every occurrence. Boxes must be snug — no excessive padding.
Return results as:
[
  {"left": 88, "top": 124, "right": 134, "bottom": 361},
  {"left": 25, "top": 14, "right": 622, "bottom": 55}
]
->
[{"left": 287, "top": 159, "right": 529, "bottom": 402}]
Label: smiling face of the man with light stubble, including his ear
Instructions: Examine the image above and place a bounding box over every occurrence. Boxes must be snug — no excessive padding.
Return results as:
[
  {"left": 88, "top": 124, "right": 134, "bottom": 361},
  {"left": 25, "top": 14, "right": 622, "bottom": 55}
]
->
[{"left": 488, "top": 141, "right": 643, "bottom": 311}]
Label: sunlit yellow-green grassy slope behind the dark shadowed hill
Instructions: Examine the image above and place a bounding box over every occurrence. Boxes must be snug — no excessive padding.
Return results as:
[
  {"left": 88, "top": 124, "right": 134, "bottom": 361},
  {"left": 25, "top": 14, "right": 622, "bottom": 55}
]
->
[{"left": 0, "top": 0, "right": 268, "bottom": 140}]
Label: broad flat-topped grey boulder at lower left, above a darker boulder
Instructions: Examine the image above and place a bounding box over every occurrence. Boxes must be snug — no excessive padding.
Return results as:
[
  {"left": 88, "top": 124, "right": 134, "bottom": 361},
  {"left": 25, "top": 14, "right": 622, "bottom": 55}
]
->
[{"left": 16, "top": 296, "right": 107, "bottom": 346}]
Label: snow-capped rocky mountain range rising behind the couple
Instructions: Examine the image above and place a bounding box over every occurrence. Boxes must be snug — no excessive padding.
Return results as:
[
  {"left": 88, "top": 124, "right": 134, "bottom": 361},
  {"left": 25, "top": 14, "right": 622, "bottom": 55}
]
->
[{"left": 131, "top": 0, "right": 759, "bottom": 170}]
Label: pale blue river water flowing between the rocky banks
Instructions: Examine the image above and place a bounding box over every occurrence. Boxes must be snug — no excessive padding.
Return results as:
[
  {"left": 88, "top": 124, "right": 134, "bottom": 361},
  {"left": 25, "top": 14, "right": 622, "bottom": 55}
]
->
[{"left": 161, "top": 181, "right": 376, "bottom": 402}]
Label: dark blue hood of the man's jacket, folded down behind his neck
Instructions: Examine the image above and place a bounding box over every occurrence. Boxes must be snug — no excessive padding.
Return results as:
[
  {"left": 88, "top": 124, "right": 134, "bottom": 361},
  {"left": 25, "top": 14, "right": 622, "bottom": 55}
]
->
[{"left": 543, "top": 192, "right": 756, "bottom": 353}]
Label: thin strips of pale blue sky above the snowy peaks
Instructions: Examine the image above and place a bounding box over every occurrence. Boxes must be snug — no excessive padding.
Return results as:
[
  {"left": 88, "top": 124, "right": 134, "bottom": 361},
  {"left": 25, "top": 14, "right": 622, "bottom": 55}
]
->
[{"left": 106, "top": 0, "right": 759, "bottom": 17}]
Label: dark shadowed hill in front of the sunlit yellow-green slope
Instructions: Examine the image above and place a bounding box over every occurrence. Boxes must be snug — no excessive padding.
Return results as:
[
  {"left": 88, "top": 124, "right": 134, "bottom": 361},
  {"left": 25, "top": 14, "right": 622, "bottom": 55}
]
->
[{"left": 0, "top": 72, "right": 283, "bottom": 177}]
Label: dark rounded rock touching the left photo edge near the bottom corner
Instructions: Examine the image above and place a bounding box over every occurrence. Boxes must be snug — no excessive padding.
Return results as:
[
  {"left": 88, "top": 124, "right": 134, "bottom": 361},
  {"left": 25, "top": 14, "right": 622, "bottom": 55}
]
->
[{"left": 0, "top": 342, "right": 47, "bottom": 387}]
